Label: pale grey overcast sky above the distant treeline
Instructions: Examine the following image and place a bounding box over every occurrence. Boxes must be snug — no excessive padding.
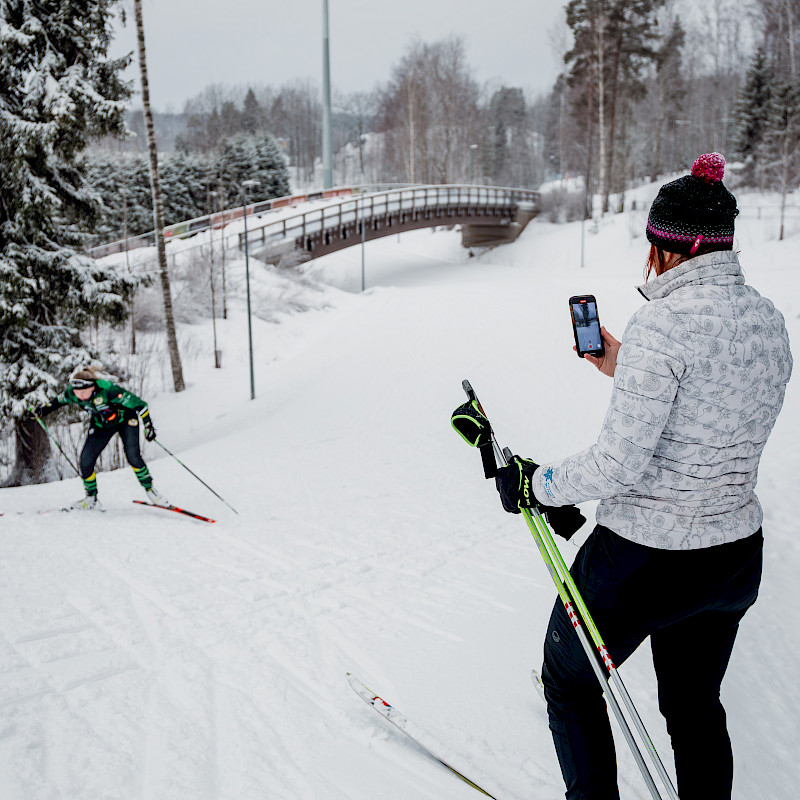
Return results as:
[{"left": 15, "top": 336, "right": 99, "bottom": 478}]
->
[{"left": 112, "top": 0, "right": 564, "bottom": 111}]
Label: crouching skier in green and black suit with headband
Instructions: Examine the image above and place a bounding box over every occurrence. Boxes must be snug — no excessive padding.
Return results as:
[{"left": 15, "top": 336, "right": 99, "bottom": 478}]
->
[{"left": 34, "top": 367, "right": 169, "bottom": 510}]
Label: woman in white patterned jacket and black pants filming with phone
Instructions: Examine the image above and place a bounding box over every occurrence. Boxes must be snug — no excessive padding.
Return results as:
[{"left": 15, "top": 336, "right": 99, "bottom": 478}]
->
[{"left": 497, "top": 153, "right": 792, "bottom": 800}]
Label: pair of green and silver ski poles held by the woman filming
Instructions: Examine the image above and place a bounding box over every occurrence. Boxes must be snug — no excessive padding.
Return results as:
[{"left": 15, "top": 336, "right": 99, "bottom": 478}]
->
[{"left": 456, "top": 380, "right": 678, "bottom": 800}]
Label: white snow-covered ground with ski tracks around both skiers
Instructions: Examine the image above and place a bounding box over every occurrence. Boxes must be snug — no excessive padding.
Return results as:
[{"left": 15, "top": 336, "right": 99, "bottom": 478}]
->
[{"left": 0, "top": 189, "right": 800, "bottom": 800}]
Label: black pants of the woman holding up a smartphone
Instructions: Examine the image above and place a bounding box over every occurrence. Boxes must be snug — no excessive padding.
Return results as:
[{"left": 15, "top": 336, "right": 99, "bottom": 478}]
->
[{"left": 542, "top": 525, "right": 764, "bottom": 800}]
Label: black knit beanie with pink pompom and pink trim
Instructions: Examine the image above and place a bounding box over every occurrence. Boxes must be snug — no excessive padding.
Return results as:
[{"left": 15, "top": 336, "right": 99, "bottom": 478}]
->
[{"left": 647, "top": 153, "right": 739, "bottom": 256}]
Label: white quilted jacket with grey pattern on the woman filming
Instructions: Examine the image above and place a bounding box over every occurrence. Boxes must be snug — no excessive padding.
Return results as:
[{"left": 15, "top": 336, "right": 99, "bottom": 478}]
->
[{"left": 534, "top": 251, "right": 792, "bottom": 550}]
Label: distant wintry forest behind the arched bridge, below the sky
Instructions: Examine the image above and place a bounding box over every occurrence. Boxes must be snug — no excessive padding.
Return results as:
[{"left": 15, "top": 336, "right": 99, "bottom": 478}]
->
[{"left": 83, "top": 0, "right": 800, "bottom": 234}]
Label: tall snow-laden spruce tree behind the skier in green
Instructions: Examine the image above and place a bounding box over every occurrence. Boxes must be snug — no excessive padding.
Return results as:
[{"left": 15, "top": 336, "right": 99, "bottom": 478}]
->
[{"left": 0, "top": 0, "right": 134, "bottom": 484}]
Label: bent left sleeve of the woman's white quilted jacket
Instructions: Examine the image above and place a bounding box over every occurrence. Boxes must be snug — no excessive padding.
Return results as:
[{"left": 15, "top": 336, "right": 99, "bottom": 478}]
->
[{"left": 534, "top": 301, "right": 691, "bottom": 506}]
